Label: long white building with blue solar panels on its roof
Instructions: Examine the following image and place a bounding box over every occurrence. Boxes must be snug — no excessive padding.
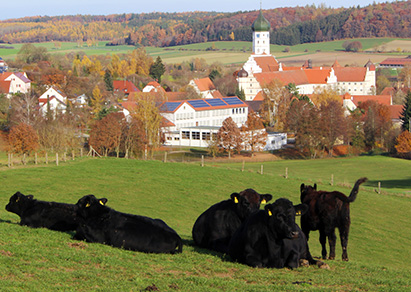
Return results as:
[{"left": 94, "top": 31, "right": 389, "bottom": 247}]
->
[{"left": 160, "top": 96, "right": 248, "bottom": 147}]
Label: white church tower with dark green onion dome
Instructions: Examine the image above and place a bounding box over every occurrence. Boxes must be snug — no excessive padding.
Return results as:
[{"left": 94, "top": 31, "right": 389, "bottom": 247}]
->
[{"left": 251, "top": 9, "right": 271, "bottom": 55}]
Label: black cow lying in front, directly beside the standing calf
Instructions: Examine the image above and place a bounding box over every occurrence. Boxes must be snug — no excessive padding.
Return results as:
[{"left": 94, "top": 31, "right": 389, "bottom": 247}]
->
[{"left": 228, "top": 198, "right": 323, "bottom": 269}]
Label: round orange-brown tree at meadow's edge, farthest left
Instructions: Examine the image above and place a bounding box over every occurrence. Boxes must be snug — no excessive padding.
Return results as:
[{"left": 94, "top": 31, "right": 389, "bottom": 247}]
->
[{"left": 9, "top": 123, "right": 39, "bottom": 154}]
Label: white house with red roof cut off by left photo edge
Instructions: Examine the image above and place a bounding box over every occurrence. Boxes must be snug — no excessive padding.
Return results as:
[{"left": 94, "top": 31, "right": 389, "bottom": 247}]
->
[{"left": 0, "top": 72, "right": 31, "bottom": 98}]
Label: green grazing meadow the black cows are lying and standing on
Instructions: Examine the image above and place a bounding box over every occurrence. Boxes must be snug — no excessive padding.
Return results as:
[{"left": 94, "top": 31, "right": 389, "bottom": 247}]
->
[{"left": 0, "top": 156, "right": 411, "bottom": 291}]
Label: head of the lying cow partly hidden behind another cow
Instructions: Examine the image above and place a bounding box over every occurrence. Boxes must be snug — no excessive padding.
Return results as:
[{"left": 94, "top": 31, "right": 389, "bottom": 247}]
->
[{"left": 231, "top": 189, "right": 273, "bottom": 218}]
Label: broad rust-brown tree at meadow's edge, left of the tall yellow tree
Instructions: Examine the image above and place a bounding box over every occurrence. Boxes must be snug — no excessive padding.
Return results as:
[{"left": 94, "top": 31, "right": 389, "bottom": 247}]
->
[{"left": 89, "top": 113, "right": 124, "bottom": 157}]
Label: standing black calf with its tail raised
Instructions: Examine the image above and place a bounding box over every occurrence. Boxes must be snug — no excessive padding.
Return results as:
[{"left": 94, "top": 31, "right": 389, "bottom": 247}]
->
[{"left": 300, "top": 178, "right": 367, "bottom": 261}]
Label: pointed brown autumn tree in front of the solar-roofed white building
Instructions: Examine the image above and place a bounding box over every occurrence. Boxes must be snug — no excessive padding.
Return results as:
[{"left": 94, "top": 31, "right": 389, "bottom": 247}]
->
[{"left": 217, "top": 117, "right": 241, "bottom": 157}]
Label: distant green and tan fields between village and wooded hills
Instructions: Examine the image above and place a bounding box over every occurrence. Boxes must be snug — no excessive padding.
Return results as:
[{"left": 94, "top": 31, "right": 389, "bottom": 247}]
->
[{"left": 0, "top": 38, "right": 411, "bottom": 66}]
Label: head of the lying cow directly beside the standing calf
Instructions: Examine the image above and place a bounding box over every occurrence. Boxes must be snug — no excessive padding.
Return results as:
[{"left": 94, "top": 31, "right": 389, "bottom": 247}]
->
[{"left": 264, "top": 198, "right": 308, "bottom": 239}]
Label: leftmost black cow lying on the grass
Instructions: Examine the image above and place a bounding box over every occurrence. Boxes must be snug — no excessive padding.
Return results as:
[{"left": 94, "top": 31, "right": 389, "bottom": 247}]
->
[{"left": 6, "top": 192, "right": 78, "bottom": 231}]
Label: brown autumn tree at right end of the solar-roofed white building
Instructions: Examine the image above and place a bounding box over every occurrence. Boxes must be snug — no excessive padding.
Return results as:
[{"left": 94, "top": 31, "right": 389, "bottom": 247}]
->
[{"left": 241, "top": 112, "right": 267, "bottom": 155}]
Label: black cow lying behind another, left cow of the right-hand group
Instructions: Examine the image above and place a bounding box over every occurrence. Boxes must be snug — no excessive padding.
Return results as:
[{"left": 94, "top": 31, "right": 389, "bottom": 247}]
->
[{"left": 192, "top": 189, "right": 273, "bottom": 253}]
